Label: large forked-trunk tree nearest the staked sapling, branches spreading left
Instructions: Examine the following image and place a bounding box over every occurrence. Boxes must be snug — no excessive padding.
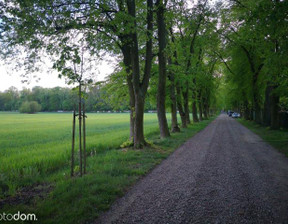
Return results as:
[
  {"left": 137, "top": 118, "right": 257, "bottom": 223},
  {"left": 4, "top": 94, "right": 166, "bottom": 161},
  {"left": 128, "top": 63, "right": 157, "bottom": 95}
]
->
[{"left": 0, "top": 0, "right": 153, "bottom": 148}]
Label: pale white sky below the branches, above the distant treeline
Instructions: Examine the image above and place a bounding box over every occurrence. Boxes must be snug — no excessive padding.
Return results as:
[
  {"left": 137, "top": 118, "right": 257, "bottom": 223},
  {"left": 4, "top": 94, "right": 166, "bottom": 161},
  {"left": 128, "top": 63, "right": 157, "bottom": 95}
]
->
[{"left": 0, "top": 58, "right": 114, "bottom": 92}]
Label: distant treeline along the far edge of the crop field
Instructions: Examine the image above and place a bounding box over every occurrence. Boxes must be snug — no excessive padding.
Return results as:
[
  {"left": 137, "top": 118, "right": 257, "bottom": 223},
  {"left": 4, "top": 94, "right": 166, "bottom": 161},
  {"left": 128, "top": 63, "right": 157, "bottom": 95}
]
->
[{"left": 0, "top": 86, "right": 155, "bottom": 112}]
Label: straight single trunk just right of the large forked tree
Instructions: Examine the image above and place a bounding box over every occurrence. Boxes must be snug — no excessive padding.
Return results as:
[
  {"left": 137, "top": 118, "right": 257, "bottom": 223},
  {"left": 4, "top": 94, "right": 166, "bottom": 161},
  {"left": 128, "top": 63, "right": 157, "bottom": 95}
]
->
[{"left": 156, "top": 0, "right": 170, "bottom": 138}]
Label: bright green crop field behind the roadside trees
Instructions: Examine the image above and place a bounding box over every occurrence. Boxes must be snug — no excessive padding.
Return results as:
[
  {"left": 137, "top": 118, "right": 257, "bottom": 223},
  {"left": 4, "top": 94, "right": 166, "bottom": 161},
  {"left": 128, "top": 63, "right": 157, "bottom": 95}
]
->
[{"left": 0, "top": 113, "right": 162, "bottom": 191}]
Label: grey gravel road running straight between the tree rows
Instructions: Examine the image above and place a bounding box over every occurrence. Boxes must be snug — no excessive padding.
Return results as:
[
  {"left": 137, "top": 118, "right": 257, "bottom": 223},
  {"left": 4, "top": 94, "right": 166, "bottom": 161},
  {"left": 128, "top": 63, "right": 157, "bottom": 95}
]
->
[{"left": 96, "top": 114, "right": 288, "bottom": 224}]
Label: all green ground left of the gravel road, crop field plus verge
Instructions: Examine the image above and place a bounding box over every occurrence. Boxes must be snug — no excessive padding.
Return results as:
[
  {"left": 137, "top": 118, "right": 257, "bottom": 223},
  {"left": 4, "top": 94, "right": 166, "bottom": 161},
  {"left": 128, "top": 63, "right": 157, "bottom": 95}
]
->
[{"left": 0, "top": 112, "right": 212, "bottom": 223}]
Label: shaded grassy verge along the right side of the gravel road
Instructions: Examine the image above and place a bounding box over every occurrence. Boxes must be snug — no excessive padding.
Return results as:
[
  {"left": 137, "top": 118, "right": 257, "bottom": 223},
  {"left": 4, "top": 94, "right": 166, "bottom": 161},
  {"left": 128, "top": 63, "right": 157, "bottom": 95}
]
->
[{"left": 239, "top": 119, "right": 288, "bottom": 157}]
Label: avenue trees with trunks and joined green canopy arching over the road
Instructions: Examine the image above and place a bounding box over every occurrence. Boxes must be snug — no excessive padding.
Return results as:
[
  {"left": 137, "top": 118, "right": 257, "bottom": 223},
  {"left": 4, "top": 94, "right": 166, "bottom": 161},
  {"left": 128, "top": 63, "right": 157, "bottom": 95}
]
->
[{"left": 0, "top": 0, "right": 288, "bottom": 145}]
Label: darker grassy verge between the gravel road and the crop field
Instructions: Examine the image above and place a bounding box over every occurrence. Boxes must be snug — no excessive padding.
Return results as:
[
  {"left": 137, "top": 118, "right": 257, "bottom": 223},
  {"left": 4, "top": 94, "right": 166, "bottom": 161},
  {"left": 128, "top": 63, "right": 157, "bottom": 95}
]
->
[{"left": 3, "top": 116, "right": 213, "bottom": 224}]
